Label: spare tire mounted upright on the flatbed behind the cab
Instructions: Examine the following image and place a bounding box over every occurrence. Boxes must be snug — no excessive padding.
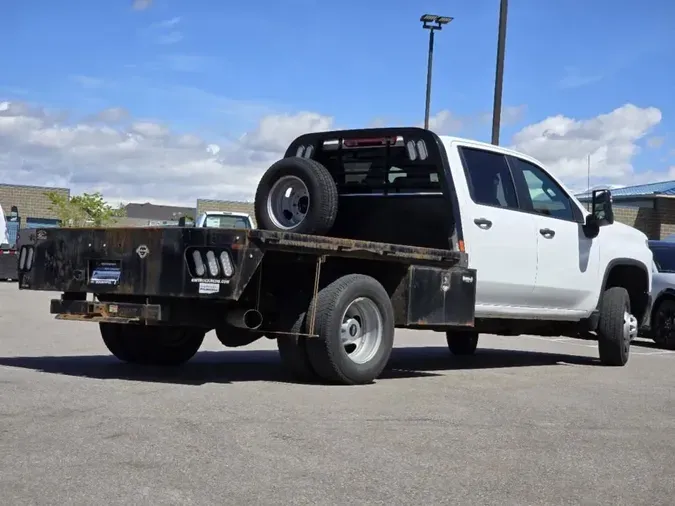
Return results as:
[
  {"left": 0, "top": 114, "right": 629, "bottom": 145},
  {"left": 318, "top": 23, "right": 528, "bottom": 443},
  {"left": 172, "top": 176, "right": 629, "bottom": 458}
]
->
[{"left": 255, "top": 156, "right": 338, "bottom": 234}]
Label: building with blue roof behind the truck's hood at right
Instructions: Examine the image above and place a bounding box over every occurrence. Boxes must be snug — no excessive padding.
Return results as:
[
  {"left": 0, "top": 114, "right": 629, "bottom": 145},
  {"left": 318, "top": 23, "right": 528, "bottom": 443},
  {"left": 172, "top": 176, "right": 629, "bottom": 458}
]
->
[{"left": 576, "top": 180, "right": 675, "bottom": 239}]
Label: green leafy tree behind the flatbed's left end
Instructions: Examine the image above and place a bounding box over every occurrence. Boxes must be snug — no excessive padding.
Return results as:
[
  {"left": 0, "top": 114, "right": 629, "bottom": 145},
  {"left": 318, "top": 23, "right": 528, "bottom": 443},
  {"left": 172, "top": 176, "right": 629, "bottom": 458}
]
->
[{"left": 46, "top": 191, "right": 126, "bottom": 227}]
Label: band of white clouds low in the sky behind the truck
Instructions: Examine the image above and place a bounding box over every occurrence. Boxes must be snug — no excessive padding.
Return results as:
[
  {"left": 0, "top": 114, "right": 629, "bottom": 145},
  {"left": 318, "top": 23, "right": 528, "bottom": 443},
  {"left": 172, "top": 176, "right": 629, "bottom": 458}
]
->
[{"left": 0, "top": 102, "right": 664, "bottom": 205}]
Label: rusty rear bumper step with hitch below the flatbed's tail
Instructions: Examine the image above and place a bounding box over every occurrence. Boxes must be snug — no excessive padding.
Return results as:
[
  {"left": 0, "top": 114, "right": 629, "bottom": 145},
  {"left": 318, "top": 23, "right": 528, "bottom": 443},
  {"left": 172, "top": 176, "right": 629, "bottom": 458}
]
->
[{"left": 49, "top": 299, "right": 168, "bottom": 323}]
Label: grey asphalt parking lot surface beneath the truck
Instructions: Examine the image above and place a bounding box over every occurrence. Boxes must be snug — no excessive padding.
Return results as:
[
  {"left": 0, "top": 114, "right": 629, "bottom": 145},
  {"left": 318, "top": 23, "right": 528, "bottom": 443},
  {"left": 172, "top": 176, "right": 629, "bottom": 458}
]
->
[{"left": 0, "top": 283, "right": 675, "bottom": 506}]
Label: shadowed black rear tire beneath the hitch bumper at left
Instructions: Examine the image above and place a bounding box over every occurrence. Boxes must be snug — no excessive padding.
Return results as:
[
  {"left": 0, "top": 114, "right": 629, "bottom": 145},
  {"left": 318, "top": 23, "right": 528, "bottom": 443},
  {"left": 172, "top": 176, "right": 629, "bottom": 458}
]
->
[{"left": 101, "top": 323, "right": 206, "bottom": 366}]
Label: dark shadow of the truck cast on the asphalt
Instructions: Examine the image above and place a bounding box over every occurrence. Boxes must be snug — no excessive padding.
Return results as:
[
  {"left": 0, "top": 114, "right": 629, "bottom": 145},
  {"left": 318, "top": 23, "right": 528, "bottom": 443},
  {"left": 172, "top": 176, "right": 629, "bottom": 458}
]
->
[{"left": 0, "top": 346, "right": 599, "bottom": 385}]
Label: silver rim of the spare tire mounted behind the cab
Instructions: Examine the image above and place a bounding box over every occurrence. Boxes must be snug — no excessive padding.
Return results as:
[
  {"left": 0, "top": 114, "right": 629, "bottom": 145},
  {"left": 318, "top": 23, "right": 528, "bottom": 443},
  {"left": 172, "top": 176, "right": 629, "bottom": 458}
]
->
[{"left": 267, "top": 176, "right": 309, "bottom": 230}]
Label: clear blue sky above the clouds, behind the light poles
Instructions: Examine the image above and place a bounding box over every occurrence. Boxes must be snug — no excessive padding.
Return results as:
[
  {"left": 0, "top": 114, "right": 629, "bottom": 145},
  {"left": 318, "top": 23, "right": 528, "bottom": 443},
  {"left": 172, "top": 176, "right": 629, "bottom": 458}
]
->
[{"left": 0, "top": 0, "right": 675, "bottom": 202}]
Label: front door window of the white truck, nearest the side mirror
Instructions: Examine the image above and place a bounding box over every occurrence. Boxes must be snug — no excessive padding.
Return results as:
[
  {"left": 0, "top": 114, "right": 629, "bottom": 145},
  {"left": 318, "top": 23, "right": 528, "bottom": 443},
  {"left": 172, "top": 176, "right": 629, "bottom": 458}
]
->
[{"left": 512, "top": 157, "right": 574, "bottom": 220}]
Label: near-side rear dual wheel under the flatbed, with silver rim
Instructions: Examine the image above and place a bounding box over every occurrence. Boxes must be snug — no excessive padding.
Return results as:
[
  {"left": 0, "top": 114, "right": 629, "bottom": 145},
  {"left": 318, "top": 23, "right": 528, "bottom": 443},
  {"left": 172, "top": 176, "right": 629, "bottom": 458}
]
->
[{"left": 305, "top": 274, "right": 394, "bottom": 385}]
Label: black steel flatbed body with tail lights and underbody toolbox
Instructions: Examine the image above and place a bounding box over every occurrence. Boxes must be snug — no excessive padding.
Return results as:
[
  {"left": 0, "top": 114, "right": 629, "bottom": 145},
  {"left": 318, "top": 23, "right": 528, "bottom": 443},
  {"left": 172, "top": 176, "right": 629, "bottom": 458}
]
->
[{"left": 19, "top": 227, "right": 476, "bottom": 331}]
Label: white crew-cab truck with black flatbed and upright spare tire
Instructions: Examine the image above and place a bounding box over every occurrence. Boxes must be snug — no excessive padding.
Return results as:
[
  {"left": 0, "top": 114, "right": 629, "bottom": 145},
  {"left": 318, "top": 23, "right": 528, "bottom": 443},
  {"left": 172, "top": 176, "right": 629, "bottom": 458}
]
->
[{"left": 19, "top": 128, "right": 652, "bottom": 384}]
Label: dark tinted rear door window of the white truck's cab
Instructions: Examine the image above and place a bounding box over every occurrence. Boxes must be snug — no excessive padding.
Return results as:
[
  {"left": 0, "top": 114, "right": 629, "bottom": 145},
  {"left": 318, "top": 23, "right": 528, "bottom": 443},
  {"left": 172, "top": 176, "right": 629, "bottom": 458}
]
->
[{"left": 460, "top": 147, "right": 518, "bottom": 209}]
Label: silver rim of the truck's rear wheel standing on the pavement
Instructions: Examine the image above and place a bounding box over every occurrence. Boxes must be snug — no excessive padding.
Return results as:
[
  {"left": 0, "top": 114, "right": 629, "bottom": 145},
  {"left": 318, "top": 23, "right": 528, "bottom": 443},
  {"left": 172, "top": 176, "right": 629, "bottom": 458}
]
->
[{"left": 340, "top": 297, "right": 384, "bottom": 364}]
